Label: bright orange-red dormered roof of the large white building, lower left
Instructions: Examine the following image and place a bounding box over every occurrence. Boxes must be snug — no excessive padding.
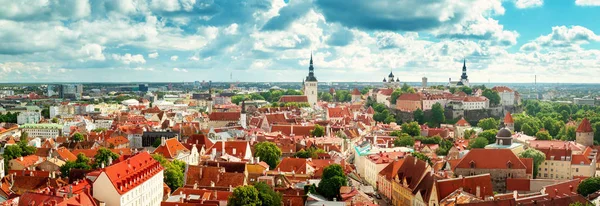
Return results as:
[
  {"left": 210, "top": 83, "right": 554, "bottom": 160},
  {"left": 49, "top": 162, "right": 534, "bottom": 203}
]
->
[{"left": 102, "top": 152, "right": 163, "bottom": 194}]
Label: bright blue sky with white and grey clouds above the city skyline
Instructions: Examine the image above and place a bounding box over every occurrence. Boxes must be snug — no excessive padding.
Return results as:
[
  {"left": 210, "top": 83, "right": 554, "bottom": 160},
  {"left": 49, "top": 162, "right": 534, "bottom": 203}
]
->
[{"left": 0, "top": 0, "right": 600, "bottom": 83}]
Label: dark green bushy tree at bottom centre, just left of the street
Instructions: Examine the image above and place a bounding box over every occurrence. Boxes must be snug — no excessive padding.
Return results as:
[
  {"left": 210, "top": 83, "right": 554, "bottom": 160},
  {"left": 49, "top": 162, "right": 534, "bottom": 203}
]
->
[{"left": 317, "top": 164, "right": 348, "bottom": 199}]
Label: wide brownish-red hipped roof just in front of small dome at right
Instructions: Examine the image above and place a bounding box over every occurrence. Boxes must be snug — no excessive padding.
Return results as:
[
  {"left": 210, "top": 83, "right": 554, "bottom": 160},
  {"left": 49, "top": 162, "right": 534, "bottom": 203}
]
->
[{"left": 456, "top": 149, "right": 527, "bottom": 170}]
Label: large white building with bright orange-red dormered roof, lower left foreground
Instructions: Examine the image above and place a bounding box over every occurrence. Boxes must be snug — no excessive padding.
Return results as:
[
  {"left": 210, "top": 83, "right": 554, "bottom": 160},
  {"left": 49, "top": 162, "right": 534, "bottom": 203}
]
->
[{"left": 88, "top": 152, "right": 164, "bottom": 206}]
